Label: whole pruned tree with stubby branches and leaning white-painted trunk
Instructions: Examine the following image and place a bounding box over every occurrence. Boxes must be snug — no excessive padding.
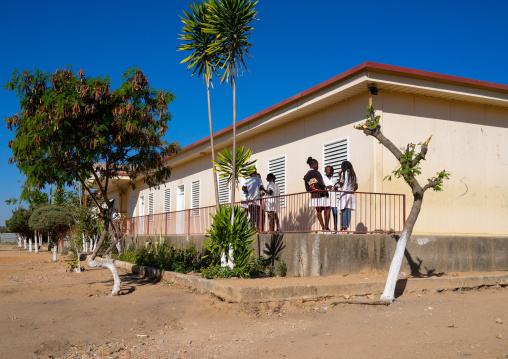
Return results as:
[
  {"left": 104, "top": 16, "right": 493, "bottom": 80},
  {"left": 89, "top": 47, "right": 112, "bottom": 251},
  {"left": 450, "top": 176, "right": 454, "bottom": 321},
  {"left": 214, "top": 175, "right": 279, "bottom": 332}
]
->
[{"left": 355, "top": 105, "right": 450, "bottom": 302}]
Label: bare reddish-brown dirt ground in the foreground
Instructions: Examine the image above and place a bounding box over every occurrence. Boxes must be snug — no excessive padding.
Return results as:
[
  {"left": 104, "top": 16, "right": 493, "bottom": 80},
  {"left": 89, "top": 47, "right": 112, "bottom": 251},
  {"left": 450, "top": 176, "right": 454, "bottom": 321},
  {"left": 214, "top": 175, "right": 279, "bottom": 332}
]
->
[{"left": 0, "top": 244, "right": 508, "bottom": 359}]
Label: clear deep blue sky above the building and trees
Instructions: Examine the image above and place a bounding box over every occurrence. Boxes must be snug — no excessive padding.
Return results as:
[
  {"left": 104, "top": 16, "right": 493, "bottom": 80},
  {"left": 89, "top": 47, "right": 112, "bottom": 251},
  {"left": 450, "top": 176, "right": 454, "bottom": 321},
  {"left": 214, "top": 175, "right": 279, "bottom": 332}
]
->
[{"left": 0, "top": 0, "right": 508, "bottom": 225}]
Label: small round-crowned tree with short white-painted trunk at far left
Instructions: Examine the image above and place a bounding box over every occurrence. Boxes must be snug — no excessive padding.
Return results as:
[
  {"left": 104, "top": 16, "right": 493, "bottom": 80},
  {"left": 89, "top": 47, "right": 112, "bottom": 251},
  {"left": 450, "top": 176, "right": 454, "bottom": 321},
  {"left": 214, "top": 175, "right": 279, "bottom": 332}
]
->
[{"left": 28, "top": 205, "right": 74, "bottom": 262}]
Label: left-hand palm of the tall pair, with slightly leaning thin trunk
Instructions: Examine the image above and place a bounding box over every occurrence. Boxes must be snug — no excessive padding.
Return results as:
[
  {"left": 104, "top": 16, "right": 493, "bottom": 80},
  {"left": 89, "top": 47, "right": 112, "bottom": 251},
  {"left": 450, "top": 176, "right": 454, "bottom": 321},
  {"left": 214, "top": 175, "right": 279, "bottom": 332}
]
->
[{"left": 178, "top": 0, "right": 222, "bottom": 210}]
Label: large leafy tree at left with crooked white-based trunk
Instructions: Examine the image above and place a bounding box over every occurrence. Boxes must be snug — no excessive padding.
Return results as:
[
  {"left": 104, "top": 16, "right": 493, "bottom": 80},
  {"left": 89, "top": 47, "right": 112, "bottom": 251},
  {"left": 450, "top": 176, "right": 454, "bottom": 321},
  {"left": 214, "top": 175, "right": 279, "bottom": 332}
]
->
[{"left": 4, "top": 68, "right": 178, "bottom": 294}]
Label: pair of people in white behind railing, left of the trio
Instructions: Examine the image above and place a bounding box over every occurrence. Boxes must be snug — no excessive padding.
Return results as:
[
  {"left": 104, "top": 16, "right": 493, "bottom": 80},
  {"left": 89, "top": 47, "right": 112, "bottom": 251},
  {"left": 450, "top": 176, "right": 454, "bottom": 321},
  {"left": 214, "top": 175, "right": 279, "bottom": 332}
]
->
[{"left": 242, "top": 172, "right": 280, "bottom": 232}]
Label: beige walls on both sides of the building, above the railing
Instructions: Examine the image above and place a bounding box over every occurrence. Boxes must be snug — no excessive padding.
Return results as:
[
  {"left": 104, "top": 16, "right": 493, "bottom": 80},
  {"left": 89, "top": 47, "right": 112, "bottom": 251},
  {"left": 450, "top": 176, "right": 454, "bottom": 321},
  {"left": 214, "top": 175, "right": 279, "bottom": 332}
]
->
[{"left": 115, "top": 91, "right": 508, "bottom": 235}]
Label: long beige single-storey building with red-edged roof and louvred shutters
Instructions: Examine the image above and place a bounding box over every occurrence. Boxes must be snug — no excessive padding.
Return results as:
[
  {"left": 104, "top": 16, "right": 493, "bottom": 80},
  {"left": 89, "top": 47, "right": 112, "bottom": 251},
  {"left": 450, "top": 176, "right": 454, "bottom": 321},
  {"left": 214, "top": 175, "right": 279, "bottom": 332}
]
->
[{"left": 110, "top": 62, "right": 508, "bottom": 237}]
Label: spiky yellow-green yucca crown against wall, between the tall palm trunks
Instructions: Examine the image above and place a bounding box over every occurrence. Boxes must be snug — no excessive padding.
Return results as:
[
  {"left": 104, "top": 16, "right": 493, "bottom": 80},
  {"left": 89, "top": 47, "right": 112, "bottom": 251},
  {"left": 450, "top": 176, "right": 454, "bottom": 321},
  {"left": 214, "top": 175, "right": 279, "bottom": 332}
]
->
[{"left": 212, "top": 146, "right": 257, "bottom": 191}]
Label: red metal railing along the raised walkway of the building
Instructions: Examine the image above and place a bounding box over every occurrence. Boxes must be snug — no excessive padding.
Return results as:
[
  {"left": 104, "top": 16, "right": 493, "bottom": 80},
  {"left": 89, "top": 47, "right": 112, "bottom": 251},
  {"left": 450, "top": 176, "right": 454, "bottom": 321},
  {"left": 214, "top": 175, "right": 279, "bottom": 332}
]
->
[{"left": 124, "top": 191, "right": 406, "bottom": 235}]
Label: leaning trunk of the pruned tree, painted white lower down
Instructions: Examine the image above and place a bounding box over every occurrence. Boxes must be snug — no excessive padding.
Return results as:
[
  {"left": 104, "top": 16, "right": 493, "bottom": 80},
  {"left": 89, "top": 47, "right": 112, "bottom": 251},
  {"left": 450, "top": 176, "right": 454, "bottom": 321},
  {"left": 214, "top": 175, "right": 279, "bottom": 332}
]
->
[{"left": 380, "top": 194, "right": 423, "bottom": 303}]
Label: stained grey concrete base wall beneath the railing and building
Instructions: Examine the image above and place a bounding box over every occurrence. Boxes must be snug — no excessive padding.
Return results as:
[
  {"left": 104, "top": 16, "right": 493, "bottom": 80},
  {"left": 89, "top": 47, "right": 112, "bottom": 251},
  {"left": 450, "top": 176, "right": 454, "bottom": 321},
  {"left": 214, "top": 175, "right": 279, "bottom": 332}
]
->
[{"left": 124, "top": 233, "right": 508, "bottom": 277}]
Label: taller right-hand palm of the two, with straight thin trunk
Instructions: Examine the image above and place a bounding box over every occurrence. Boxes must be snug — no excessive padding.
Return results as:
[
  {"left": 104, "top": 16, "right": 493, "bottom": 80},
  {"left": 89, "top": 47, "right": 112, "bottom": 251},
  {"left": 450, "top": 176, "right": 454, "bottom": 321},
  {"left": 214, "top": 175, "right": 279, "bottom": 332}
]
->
[{"left": 204, "top": 0, "right": 258, "bottom": 224}]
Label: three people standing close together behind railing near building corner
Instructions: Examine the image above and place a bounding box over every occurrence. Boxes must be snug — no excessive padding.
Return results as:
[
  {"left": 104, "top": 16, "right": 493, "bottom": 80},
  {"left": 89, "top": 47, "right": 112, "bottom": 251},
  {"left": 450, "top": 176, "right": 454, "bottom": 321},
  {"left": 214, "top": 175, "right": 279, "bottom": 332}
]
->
[{"left": 303, "top": 157, "right": 358, "bottom": 232}]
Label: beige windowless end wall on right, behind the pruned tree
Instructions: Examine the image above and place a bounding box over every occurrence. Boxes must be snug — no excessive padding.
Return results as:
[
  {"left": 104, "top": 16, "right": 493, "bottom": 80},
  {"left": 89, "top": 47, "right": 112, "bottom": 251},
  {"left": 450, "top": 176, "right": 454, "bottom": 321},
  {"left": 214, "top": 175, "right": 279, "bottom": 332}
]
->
[{"left": 380, "top": 92, "right": 508, "bottom": 235}]
